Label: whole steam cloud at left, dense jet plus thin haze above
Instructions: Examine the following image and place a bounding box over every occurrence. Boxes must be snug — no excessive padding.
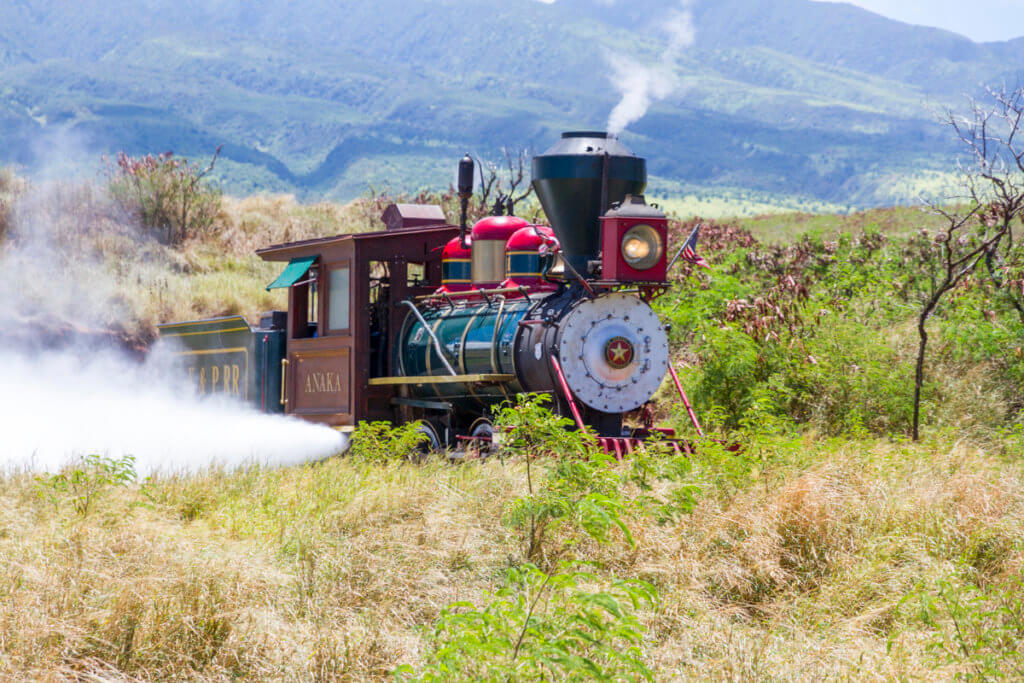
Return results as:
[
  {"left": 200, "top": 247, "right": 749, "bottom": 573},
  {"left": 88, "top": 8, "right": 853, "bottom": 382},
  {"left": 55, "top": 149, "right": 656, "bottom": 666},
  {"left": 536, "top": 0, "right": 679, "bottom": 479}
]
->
[{"left": 0, "top": 141, "right": 345, "bottom": 476}]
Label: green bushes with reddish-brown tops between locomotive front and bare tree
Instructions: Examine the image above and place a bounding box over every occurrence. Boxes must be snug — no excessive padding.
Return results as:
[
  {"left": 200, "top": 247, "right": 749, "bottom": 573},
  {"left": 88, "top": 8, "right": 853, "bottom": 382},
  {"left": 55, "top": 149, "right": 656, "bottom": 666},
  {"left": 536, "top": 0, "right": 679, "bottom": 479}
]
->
[{"left": 658, "top": 225, "right": 942, "bottom": 434}]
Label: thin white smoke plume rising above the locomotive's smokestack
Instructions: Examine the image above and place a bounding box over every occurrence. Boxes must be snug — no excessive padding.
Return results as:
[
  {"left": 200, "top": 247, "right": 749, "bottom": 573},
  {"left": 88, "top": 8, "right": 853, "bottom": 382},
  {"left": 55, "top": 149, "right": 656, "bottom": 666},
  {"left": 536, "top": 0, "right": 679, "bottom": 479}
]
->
[{"left": 605, "top": 0, "right": 696, "bottom": 135}]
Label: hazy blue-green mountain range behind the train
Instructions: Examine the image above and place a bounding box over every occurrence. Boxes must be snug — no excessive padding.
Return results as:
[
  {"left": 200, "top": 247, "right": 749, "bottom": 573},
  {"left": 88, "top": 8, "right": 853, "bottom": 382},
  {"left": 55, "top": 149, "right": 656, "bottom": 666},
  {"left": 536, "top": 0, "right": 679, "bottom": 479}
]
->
[{"left": 0, "top": 0, "right": 1024, "bottom": 206}]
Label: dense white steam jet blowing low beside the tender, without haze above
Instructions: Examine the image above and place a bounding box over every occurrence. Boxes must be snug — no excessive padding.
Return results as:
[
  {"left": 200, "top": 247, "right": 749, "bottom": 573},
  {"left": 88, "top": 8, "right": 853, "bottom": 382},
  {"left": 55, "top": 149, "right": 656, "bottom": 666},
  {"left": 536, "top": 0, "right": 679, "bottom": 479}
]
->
[{"left": 0, "top": 349, "right": 343, "bottom": 477}]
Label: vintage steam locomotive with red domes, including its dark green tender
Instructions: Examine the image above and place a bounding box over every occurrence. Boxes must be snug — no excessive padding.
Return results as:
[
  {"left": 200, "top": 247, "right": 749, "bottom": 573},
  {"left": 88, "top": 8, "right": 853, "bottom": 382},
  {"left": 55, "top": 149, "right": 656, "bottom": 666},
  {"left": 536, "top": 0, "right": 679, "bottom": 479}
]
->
[{"left": 160, "top": 132, "right": 699, "bottom": 455}]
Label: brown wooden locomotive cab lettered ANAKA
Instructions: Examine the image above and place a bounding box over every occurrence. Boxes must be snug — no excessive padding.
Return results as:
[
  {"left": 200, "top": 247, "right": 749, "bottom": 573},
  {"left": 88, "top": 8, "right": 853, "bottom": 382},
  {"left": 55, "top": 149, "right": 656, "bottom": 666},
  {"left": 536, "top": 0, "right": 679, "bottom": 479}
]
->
[{"left": 257, "top": 224, "right": 459, "bottom": 427}]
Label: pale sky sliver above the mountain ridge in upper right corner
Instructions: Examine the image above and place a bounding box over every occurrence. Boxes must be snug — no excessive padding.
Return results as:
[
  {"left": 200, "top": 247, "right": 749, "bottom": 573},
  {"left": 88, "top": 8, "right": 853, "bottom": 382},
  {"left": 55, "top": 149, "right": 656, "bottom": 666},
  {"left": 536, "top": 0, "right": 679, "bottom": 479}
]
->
[{"left": 823, "top": 0, "right": 1024, "bottom": 41}]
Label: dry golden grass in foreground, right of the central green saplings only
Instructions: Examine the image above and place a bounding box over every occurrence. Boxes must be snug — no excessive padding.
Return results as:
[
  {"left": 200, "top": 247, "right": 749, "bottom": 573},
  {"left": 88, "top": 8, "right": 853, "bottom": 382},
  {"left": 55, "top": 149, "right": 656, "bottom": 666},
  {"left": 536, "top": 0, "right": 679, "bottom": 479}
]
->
[{"left": 638, "top": 436, "right": 1024, "bottom": 679}]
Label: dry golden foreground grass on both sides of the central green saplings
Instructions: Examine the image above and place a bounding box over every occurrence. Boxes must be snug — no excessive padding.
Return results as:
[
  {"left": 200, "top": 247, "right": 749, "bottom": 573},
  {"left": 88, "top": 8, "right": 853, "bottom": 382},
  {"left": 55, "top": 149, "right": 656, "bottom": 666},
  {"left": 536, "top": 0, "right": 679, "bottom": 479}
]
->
[{"left": 0, "top": 438, "right": 1024, "bottom": 680}]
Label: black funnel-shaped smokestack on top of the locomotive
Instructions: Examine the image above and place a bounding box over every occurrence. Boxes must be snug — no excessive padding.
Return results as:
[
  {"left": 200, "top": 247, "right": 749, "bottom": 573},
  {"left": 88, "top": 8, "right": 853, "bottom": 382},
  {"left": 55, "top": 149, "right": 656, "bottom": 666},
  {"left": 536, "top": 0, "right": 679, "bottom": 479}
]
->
[{"left": 534, "top": 131, "right": 647, "bottom": 274}]
